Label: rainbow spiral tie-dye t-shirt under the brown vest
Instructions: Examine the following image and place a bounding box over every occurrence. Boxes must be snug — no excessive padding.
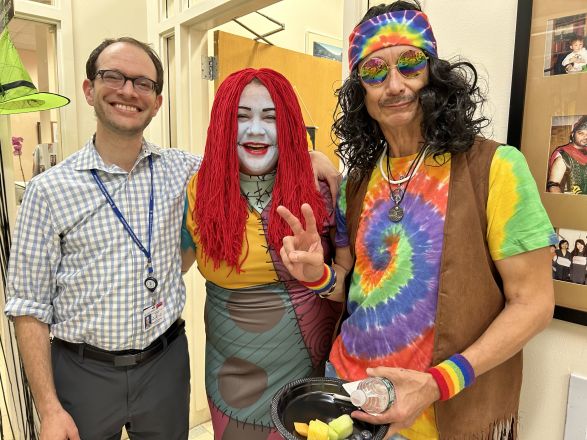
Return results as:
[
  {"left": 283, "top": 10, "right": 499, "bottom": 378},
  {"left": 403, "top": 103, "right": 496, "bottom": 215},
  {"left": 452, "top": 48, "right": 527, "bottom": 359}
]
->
[{"left": 330, "top": 146, "right": 555, "bottom": 440}]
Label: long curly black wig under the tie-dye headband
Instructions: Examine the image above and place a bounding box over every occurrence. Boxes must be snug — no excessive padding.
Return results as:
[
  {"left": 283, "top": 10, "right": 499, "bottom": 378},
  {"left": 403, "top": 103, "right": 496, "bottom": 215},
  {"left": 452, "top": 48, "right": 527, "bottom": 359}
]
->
[{"left": 332, "top": 0, "right": 489, "bottom": 174}]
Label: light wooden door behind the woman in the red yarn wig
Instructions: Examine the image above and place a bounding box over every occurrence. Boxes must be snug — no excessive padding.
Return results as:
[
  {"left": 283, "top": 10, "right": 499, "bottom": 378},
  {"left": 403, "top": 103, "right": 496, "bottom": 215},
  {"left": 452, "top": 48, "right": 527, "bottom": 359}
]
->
[{"left": 214, "top": 31, "right": 342, "bottom": 167}]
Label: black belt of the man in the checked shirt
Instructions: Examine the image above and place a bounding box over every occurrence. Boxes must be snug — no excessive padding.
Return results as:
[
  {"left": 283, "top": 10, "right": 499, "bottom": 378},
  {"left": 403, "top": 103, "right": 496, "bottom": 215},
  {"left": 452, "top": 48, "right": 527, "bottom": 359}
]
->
[{"left": 53, "top": 319, "right": 185, "bottom": 367}]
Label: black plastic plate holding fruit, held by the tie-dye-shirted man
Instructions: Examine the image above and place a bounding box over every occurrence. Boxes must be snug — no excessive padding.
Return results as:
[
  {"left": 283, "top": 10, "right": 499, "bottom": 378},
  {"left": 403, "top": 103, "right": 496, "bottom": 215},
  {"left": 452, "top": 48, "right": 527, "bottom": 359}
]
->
[{"left": 271, "top": 377, "right": 387, "bottom": 440}]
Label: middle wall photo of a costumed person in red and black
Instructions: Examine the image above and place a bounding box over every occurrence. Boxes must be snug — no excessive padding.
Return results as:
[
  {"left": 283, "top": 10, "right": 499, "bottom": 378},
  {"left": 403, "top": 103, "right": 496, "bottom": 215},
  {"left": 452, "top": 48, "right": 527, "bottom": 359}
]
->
[{"left": 546, "top": 115, "right": 587, "bottom": 195}]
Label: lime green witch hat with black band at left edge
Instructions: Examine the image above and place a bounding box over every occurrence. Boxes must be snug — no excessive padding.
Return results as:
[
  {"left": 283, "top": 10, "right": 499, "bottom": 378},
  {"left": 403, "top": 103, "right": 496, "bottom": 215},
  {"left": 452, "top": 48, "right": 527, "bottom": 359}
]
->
[{"left": 0, "top": 29, "right": 69, "bottom": 115}]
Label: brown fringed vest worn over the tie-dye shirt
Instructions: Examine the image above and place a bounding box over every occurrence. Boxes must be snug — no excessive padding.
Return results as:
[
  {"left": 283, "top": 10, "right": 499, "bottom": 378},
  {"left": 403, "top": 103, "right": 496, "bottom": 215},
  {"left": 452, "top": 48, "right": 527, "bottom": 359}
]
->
[{"left": 346, "top": 138, "right": 522, "bottom": 440}]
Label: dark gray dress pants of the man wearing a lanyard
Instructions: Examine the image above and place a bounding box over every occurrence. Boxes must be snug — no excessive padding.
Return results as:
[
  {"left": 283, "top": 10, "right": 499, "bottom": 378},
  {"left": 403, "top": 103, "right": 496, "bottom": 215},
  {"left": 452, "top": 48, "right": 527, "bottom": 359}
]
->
[{"left": 51, "top": 334, "right": 190, "bottom": 440}]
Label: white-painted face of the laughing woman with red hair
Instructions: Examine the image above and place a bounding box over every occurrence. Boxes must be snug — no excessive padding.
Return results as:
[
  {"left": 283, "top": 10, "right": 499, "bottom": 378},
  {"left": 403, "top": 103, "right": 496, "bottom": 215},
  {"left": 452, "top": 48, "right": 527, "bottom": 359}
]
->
[{"left": 237, "top": 82, "right": 279, "bottom": 176}]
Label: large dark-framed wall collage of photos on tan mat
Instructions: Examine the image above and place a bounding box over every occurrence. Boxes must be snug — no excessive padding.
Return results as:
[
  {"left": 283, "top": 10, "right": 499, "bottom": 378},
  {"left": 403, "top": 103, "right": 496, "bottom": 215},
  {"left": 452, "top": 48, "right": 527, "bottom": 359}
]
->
[{"left": 507, "top": 0, "right": 587, "bottom": 325}]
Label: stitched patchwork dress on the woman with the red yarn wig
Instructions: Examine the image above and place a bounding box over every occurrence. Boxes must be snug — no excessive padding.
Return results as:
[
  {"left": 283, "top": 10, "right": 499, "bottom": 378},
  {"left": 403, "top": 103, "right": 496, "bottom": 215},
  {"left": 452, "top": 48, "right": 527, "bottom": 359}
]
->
[{"left": 182, "top": 175, "right": 342, "bottom": 440}]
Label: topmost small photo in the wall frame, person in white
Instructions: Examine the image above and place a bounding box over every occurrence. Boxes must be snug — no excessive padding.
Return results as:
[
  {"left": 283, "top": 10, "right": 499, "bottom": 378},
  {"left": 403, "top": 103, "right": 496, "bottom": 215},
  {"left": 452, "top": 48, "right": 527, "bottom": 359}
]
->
[{"left": 544, "top": 14, "right": 587, "bottom": 76}]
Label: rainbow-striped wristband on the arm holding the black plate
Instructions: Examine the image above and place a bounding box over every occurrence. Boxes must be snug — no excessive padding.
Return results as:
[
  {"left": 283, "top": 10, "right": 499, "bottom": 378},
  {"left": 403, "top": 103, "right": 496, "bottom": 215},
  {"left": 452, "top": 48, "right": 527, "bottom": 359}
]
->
[{"left": 427, "top": 353, "right": 475, "bottom": 400}]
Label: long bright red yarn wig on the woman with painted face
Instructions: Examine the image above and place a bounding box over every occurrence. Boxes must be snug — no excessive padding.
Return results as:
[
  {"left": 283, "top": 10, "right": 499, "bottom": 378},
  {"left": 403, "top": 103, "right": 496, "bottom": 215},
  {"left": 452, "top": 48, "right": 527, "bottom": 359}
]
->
[{"left": 192, "top": 68, "right": 327, "bottom": 272}]
